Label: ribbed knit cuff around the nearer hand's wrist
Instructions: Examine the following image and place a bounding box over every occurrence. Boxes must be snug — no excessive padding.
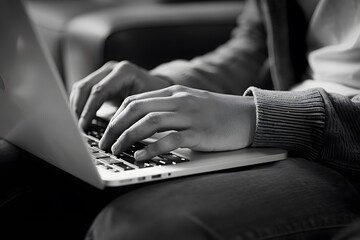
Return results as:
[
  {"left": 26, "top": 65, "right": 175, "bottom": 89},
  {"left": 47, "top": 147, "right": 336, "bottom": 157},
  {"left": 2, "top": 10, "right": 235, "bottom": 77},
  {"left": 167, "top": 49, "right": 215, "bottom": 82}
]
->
[{"left": 244, "top": 87, "right": 325, "bottom": 160}]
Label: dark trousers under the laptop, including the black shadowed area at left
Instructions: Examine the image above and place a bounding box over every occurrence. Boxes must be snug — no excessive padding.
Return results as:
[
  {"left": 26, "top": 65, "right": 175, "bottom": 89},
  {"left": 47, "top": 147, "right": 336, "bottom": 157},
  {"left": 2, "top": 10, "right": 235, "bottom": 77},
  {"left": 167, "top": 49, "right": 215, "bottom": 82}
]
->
[{"left": 0, "top": 139, "right": 360, "bottom": 240}]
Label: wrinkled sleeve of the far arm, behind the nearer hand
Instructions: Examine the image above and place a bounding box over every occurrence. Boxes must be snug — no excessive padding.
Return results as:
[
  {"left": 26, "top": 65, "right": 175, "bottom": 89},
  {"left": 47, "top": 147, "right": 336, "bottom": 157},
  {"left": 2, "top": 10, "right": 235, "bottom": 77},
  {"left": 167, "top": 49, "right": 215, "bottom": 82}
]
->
[{"left": 151, "top": 0, "right": 267, "bottom": 94}]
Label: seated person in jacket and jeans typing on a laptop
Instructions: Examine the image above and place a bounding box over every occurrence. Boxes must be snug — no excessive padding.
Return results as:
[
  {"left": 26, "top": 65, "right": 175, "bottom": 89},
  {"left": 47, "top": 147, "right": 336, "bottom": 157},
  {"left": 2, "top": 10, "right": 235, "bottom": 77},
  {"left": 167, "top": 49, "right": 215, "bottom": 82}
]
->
[{"left": 70, "top": 0, "right": 360, "bottom": 239}]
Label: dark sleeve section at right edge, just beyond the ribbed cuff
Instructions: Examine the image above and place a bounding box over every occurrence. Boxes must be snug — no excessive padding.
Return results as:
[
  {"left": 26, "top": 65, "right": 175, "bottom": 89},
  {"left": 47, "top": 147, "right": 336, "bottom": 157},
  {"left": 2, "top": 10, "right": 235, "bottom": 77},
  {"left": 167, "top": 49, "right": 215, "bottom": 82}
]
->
[{"left": 318, "top": 90, "right": 360, "bottom": 171}]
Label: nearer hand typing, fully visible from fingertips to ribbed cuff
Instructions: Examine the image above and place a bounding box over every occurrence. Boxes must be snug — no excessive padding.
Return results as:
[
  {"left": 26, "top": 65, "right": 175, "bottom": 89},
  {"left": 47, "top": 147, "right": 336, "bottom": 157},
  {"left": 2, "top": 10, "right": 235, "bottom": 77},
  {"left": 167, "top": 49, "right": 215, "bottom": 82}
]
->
[{"left": 99, "top": 86, "right": 256, "bottom": 160}]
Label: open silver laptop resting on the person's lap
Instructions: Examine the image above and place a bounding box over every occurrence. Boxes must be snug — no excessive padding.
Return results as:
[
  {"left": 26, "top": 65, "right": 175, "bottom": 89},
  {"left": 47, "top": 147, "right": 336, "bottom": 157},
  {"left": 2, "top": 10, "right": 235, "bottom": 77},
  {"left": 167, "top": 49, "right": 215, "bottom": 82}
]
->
[{"left": 0, "top": 0, "right": 287, "bottom": 188}]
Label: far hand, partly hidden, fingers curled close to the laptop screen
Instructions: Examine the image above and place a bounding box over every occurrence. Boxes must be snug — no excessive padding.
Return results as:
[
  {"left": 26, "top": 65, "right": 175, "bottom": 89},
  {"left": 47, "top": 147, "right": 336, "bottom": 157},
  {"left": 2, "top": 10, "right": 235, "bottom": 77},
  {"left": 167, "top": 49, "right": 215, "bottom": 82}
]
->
[{"left": 70, "top": 61, "right": 171, "bottom": 129}]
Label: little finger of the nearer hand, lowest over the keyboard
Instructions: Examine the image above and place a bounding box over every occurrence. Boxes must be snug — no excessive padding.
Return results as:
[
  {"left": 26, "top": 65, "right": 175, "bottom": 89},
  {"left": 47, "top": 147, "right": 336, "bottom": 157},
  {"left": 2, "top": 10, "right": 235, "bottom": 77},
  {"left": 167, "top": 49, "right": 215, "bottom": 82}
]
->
[{"left": 134, "top": 130, "right": 198, "bottom": 161}]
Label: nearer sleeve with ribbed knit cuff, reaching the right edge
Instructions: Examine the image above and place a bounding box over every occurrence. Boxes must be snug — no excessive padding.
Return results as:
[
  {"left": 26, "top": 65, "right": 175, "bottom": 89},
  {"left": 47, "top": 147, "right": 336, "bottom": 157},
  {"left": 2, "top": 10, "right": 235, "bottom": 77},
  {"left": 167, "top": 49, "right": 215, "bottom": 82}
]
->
[{"left": 245, "top": 87, "right": 360, "bottom": 173}]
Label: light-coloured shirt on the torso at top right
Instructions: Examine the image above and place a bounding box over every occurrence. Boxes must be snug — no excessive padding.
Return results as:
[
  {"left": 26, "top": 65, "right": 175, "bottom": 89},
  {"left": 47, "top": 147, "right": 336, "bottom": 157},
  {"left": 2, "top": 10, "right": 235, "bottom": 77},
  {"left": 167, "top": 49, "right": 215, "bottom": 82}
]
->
[{"left": 292, "top": 0, "right": 360, "bottom": 96}]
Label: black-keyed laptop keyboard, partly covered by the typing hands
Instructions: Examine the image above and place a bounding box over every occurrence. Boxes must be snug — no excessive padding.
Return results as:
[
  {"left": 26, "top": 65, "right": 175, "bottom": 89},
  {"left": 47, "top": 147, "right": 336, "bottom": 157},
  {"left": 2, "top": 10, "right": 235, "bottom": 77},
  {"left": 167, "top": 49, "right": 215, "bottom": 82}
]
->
[{"left": 84, "top": 118, "right": 189, "bottom": 173}]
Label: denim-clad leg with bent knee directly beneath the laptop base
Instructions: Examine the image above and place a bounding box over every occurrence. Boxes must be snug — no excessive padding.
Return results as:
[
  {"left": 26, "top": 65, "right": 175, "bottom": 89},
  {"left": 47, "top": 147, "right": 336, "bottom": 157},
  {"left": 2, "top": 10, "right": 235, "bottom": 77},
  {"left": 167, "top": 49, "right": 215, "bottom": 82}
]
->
[{"left": 87, "top": 158, "right": 360, "bottom": 240}]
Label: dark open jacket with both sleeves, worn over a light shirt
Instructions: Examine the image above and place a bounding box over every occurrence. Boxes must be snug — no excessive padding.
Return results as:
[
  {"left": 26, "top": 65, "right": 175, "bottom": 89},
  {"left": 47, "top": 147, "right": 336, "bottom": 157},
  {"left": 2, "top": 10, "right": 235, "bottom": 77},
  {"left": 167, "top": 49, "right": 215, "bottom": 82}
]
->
[{"left": 151, "top": 0, "right": 360, "bottom": 177}]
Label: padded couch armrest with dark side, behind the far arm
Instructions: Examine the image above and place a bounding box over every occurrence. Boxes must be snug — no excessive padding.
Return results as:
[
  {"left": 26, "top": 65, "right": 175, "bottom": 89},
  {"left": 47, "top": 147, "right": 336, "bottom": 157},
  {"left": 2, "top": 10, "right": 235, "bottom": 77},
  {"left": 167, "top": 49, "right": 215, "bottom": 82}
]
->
[{"left": 63, "top": 2, "right": 242, "bottom": 88}]
